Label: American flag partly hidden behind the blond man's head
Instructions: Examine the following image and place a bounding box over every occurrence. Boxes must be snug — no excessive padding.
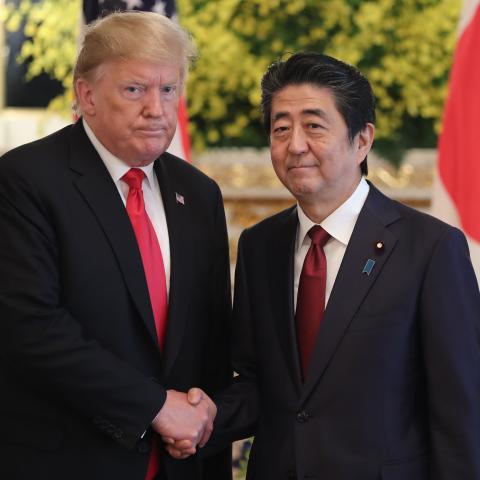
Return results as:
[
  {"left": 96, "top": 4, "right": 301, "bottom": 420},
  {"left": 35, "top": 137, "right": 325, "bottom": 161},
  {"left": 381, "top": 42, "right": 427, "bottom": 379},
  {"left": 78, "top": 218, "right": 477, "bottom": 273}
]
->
[{"left": 83, "top": 0, "right": 191, "bottom": 161}]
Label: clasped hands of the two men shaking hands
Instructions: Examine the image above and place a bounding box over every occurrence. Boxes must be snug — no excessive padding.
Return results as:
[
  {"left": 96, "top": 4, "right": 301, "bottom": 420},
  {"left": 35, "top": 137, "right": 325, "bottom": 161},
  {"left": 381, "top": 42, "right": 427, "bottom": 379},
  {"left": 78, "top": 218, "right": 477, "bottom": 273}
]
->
[{"left": 152, "top": 388, "right": 217, "bottom": 459}]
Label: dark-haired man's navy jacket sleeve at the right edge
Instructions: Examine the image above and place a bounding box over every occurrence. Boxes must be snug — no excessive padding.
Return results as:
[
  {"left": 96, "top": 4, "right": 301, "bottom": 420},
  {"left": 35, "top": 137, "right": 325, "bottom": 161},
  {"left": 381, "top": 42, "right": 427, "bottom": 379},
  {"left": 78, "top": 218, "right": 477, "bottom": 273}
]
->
[{"left": 420, "top": 228, "right": 480, "bottom": 480}]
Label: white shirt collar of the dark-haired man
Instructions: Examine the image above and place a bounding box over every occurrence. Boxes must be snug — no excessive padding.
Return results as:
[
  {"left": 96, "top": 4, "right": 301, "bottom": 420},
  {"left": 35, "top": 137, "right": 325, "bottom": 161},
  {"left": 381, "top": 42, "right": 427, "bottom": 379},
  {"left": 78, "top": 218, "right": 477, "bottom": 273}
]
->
[{"left": 297, "top": 176, "right": 370, "bottom": 250}]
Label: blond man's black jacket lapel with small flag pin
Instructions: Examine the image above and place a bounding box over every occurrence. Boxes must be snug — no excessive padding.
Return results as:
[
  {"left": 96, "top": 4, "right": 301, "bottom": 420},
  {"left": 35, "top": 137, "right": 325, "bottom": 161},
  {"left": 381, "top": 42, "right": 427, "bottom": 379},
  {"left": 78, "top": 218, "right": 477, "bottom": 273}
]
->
[{"left": 154, "top": 158, "right": 195, "bottom": 375}]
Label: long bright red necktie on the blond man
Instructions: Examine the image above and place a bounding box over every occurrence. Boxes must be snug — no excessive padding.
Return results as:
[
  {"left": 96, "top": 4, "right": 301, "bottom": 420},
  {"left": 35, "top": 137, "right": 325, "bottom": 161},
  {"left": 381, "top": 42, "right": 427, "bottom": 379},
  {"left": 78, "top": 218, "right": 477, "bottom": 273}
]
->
[{"left": 122, "top": 168, "right": 168, "bottom": 480}]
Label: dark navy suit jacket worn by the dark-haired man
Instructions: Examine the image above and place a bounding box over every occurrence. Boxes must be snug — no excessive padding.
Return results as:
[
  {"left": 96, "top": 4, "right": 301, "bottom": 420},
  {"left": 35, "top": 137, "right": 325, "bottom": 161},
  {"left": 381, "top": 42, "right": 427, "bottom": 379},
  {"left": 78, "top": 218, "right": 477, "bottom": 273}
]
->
[{"left": 216, "top": 187, "right": 480, "bottom": 480}]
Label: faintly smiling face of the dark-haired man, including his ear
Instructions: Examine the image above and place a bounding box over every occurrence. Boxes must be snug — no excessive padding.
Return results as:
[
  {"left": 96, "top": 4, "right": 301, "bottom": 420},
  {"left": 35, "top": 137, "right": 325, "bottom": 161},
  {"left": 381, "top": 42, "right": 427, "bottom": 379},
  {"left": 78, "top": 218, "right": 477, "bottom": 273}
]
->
[{"left": 270, "top": 83, "right": 374, "bottom": 212}]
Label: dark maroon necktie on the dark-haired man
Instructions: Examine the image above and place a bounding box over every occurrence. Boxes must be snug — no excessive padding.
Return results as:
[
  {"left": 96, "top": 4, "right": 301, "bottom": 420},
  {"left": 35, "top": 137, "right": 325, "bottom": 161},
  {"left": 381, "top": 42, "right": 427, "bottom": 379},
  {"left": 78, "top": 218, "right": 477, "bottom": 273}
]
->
[{"left": 295, "top": 225, "right": 330, "bottom": 379}]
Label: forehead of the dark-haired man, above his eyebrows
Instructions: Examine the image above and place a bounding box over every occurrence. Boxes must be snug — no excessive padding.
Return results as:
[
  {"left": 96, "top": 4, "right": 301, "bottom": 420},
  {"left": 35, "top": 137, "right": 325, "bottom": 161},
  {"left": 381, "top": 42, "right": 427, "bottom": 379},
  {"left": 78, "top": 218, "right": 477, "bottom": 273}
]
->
[{"left": 271, "top": 83, "right": 339, "bottom": 118}]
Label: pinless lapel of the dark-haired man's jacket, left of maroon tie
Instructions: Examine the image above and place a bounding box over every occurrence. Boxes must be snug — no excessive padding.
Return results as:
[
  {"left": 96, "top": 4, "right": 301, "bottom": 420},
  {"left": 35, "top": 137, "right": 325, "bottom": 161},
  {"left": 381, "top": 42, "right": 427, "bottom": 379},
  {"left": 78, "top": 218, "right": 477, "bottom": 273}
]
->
[{"left": 268, "top": 207, "right": 301, "bottom": 391}]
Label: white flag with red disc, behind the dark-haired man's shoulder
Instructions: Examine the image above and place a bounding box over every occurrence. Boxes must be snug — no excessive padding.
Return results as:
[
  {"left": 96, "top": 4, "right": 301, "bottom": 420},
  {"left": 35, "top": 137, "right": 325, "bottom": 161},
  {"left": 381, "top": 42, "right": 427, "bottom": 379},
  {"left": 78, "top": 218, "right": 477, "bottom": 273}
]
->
[{"left": 432, "top": 0, "right": 480, "bottom": 280}]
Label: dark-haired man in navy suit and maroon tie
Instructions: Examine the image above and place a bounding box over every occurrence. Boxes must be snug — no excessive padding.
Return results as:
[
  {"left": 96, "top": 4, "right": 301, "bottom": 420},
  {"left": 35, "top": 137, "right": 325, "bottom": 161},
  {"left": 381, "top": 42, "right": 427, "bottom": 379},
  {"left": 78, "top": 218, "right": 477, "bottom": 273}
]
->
[{"left": 170, "top": 53, "right": 480, "bottom": 480}]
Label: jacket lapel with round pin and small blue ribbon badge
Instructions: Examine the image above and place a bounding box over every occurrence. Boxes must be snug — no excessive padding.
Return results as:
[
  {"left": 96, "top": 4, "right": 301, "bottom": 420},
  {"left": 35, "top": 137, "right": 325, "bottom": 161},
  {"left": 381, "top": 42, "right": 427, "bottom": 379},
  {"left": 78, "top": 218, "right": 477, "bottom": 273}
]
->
[{"left": 301, "top": 186, "right": 400, "bottom": 403}]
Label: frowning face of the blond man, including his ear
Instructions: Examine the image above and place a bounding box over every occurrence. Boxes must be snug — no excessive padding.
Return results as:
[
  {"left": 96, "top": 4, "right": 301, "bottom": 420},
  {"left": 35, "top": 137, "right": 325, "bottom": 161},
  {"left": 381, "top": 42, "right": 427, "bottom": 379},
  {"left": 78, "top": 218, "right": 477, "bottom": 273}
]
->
[{"left": 76, "top": 60, "right": 181, "bottom": 166}]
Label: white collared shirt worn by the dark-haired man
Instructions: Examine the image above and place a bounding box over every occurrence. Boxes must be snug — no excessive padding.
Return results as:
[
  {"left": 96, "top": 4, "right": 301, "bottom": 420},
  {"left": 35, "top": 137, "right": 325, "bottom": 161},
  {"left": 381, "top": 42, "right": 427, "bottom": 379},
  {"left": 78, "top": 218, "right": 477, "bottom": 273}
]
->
[{"left": 293, "top": 177, "right": 370, "bottom": 310}]
